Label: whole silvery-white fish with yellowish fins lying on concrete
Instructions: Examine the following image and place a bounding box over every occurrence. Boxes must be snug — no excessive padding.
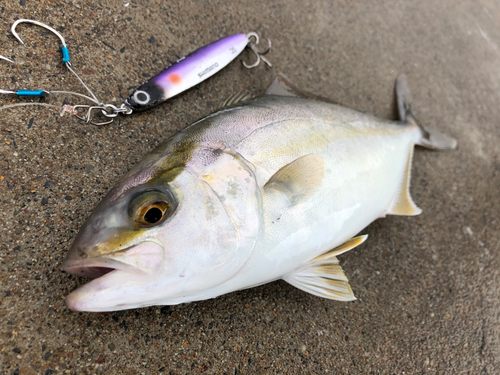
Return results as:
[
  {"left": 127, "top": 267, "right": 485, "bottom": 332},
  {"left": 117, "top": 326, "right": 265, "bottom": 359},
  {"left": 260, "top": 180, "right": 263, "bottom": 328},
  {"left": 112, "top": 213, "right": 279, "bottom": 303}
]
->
[{"left": 63, "top": 76, "right": 456, "bottom": 311}]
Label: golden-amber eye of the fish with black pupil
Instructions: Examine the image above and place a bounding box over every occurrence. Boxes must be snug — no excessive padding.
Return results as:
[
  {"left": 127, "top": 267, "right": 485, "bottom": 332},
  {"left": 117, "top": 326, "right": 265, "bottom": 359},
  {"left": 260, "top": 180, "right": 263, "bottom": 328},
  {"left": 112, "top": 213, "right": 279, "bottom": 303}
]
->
[{"left": 129, "top": 190, "right": 173, "bottom": 228}]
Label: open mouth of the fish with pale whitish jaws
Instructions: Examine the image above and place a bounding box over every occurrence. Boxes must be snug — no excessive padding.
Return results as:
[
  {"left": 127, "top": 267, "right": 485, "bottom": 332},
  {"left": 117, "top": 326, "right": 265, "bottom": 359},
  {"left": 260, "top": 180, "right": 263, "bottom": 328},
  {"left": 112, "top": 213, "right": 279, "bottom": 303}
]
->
[{"left": 62, "top": 241, "right": 163, "bottom": 311}]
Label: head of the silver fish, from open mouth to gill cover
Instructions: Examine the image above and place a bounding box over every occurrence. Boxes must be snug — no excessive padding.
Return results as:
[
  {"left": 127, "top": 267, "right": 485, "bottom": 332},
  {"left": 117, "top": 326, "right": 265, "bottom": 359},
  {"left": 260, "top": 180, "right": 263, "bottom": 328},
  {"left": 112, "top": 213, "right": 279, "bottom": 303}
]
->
[{"left": 63, "top": 142, "right": 262, "bottom": 311}]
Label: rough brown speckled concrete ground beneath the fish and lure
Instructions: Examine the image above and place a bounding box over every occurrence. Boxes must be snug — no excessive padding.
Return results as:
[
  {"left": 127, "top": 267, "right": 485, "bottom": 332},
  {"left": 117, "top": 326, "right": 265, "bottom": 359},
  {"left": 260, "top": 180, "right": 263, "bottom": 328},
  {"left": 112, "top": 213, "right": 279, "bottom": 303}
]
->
[{"left": 0, "top": 0, "right": 500, "bottom": 374}]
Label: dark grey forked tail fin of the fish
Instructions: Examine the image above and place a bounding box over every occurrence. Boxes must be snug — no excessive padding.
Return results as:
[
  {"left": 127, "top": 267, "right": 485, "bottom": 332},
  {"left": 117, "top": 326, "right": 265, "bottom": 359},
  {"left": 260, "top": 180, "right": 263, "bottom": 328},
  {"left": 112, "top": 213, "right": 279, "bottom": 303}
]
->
[{"left": 396, "top": 74, "right": 457, "bottom": 150}]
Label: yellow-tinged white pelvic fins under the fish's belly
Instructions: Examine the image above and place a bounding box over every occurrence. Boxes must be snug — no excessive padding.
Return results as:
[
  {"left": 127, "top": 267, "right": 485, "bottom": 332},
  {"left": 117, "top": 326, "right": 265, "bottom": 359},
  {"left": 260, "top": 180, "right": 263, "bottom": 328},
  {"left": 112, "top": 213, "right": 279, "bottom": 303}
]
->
[{"left": 283, "top": 235, "right": 368, "bottom": 301}]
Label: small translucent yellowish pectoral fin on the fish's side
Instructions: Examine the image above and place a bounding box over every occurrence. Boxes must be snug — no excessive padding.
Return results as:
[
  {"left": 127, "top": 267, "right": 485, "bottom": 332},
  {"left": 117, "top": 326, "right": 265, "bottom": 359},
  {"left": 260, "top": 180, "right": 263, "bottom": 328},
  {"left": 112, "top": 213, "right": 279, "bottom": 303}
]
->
[{"left": 264, "top": 154, "right": 325, "bottom": 205}]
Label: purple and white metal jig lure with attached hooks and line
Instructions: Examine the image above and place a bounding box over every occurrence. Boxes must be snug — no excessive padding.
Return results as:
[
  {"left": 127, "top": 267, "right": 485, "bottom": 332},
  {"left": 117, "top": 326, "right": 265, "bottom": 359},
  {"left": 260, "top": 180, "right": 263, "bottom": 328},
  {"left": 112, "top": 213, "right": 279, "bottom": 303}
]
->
[{"left": 0, "top": 19, "right": 272, "bottom": 126}]
